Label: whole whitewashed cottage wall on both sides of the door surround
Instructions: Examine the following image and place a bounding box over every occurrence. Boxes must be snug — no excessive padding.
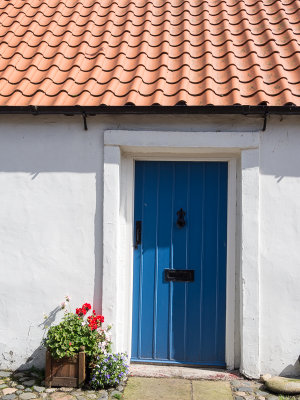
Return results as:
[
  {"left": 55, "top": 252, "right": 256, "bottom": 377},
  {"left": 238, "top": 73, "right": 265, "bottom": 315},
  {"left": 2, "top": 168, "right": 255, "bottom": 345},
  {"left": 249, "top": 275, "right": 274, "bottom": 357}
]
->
[{"left": 0, "top": 116, "right": 300, "bottom": 373}]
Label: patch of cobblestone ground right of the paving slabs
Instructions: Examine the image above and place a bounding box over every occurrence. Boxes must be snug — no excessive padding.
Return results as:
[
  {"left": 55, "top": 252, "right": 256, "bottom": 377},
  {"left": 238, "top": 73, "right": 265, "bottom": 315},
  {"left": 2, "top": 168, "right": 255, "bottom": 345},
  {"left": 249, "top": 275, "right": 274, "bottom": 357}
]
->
[{"left": 231, "top": 380, "right": 300, "bottom": 400}]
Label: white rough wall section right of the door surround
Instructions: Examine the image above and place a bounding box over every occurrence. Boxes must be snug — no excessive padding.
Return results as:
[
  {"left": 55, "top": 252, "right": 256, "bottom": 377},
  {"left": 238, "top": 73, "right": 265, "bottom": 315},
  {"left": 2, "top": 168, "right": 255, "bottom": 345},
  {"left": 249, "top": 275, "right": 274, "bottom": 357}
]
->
[{"left": 260, "top": 118, "right": 300, "bottom": 375}]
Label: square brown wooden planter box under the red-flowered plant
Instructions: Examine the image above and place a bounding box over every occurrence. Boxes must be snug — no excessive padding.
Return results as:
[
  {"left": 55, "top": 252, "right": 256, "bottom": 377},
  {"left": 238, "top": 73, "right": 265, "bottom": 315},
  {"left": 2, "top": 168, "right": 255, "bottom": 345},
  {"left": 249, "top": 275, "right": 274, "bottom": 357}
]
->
[{"left": 45, "top": 351, "right": 85, "bottom": 387}]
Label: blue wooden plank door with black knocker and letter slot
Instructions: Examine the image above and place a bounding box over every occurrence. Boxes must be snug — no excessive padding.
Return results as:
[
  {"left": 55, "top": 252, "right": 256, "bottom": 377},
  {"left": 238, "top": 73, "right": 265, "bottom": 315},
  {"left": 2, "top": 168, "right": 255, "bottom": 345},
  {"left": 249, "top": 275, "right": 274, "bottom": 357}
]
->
[{"left": 131, "top": 161, "right": 228, "bottom": 366}]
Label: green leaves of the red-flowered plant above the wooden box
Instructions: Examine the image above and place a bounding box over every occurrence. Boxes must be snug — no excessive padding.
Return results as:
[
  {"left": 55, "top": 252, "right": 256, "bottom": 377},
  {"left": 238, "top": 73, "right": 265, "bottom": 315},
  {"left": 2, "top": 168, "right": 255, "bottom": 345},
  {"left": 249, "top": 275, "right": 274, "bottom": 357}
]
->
[{"left": 44, "top": 313, "right": 100, "bottom": 358}]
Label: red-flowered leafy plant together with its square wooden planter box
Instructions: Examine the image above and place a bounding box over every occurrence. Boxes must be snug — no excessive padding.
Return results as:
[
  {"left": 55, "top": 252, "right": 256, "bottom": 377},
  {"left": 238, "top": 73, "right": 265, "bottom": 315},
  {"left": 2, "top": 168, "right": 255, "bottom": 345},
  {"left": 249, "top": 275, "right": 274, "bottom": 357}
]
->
[{"left": 43, "top": 297, "right": 111, "bottom": 387}]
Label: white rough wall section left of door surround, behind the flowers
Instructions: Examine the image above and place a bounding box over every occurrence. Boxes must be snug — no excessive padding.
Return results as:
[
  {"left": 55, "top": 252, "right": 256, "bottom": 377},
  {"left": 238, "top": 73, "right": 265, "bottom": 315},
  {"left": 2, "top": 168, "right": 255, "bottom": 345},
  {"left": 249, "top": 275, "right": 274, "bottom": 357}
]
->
[{"left": 0, "top": 117, "right": 103, "bottom": 368}]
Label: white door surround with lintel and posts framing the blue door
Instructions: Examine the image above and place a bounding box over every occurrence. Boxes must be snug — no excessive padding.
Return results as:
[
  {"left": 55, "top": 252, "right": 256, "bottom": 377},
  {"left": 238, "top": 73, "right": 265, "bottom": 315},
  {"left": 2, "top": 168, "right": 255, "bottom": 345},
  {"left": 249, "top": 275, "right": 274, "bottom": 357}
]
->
[{"left": 102, "top": 131, "right": 259, "bottom": 376}]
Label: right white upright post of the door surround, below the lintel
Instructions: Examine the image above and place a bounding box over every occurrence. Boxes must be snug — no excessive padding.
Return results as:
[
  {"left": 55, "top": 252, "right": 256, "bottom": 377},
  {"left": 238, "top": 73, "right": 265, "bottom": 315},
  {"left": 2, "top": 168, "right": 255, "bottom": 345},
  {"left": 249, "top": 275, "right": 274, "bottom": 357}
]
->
[{"left": 240, "top": 149, "right": 260, "bottom": 378}]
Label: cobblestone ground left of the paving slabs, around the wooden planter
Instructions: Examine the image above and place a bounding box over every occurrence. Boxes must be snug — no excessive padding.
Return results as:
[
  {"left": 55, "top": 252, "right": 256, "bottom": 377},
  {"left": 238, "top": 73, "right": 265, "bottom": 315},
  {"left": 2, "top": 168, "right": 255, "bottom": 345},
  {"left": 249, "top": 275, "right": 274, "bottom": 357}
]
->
[{"left": 0, "top": 371, "right": 124, "bottom": 400}]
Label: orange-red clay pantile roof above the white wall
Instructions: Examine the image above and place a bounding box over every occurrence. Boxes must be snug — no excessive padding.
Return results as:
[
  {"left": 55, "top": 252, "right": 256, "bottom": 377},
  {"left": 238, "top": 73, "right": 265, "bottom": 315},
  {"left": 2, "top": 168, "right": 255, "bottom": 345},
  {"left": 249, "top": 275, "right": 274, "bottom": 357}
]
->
[{"left": 0, "top": 0, "right": 300, "bottom": 106}]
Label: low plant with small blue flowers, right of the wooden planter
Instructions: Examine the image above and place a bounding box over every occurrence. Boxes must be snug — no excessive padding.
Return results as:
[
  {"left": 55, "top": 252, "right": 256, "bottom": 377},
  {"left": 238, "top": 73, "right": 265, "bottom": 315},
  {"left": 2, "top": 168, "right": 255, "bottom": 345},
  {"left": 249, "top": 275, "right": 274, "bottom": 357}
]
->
[{"left": 90, "top": 353, "right": 129, "bottom": 390}]
